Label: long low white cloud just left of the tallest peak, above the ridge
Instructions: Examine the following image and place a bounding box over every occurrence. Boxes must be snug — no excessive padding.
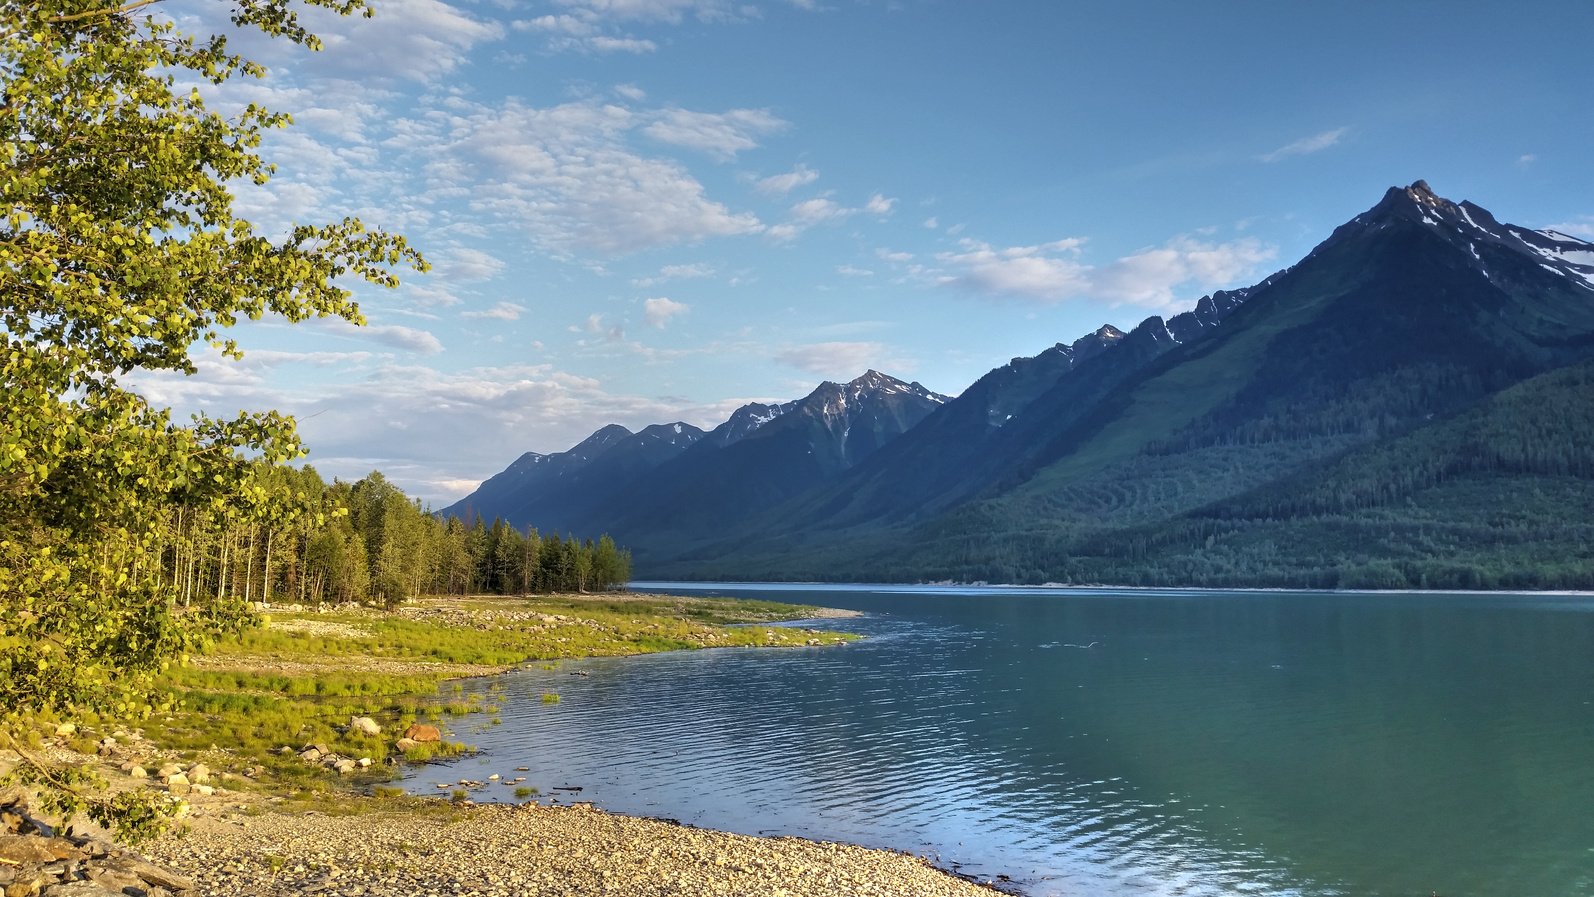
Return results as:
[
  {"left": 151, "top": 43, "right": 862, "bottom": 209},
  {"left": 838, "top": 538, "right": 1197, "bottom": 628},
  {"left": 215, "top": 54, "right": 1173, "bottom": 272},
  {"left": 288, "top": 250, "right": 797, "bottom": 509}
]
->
[{"left": 921, "top": 236, "right": 1275, "bottom": 311}]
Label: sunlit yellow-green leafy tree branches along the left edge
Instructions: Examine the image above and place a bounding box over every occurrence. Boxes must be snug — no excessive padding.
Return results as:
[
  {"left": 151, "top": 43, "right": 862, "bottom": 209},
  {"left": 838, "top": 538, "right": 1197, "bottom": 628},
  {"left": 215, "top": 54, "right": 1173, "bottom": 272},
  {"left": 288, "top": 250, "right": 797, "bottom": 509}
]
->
[{"left": 0, "top": 0, "right": 426, "bottom": 715}]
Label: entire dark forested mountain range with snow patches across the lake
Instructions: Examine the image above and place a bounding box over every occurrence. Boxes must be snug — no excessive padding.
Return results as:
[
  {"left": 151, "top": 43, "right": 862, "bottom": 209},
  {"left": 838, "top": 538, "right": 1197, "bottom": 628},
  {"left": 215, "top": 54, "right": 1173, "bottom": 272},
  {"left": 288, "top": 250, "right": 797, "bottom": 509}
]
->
[{"left": 446, "top": 182, "right": 1594, "bottom": 588}]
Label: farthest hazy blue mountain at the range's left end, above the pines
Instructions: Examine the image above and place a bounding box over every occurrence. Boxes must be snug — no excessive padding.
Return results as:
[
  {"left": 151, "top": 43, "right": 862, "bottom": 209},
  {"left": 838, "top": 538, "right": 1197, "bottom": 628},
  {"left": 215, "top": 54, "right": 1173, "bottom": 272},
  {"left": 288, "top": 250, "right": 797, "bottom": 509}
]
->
[{"left": 440, "top": 422, "right": 705, "bottom": 532}]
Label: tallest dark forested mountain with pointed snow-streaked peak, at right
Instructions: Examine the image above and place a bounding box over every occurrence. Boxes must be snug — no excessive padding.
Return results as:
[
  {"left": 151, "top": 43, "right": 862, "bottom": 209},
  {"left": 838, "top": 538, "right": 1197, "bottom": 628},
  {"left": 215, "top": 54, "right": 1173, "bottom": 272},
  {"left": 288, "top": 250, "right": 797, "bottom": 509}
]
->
[{"left": 644, "top": 182, "right": 1594, "bottom": 586}]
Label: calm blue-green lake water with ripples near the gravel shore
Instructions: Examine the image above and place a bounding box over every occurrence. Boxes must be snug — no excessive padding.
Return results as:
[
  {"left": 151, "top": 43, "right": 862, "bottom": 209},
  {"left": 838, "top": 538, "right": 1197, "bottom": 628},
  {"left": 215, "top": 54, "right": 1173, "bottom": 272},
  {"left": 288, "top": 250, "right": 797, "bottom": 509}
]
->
[{"left": 408, "top": 583, "right": 1594, "bottom": 897}]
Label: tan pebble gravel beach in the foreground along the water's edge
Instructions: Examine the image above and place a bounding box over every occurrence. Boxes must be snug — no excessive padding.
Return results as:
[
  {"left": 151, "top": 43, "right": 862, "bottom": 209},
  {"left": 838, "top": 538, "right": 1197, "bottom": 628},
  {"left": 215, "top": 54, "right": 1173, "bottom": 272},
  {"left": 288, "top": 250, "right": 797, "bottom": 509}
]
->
[{"left": 148, "top": 805, "right": 991, "bottom": 897}]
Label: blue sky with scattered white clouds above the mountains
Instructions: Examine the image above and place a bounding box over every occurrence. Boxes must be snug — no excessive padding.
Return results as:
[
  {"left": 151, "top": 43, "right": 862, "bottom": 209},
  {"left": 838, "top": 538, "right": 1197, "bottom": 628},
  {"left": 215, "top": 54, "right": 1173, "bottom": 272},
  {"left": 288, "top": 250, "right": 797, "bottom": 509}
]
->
[{"left": 137, "top": 0, "right": 1594, "bottom": 507}]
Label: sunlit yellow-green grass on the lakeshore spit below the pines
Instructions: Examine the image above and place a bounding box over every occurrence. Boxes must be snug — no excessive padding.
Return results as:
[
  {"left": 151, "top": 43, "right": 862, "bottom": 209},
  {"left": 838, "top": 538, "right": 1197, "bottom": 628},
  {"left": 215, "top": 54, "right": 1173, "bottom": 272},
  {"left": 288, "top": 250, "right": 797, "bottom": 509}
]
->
[{"left": 127, "top": 596, "right": 853, "bottom": 798}]
